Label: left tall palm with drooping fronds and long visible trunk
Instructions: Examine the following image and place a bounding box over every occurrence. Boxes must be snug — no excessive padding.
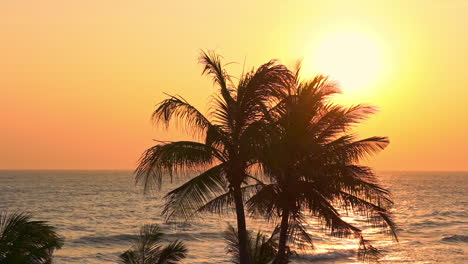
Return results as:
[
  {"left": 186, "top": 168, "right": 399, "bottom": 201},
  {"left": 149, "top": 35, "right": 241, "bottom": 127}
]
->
[{"left": 135, "top": 52, "right": 293, "bottom": 264}]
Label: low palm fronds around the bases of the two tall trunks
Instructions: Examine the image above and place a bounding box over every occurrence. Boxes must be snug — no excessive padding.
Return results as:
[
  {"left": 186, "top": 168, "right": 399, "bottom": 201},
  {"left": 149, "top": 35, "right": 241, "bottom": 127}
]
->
[{"left": 224, "top": 225, "right": 279, "bottom": 264}]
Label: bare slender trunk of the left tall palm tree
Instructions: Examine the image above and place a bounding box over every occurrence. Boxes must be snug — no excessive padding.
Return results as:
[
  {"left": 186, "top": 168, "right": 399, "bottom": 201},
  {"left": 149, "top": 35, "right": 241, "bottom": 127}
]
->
[{"left": 233, "top": 186, "right": 250, "bottom": 264}]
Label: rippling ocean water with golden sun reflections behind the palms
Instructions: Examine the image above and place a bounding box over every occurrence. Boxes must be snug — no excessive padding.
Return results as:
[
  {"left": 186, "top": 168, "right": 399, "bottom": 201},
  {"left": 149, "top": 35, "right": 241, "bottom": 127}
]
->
[{"left": 0, "top": 171, "right": 468, "bottom": 264}]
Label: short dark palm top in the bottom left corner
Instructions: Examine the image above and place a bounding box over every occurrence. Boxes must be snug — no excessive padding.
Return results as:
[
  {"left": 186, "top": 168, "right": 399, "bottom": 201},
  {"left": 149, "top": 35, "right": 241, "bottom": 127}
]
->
[{"left": 0, "top": 212, "right": 63, "bottom": 264}]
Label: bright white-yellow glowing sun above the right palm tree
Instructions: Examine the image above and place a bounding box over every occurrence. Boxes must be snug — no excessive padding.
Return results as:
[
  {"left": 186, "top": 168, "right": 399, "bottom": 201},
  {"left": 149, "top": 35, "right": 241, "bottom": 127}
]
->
[{"left": 306, "top": 32, "right": 383, "bottom": 101}]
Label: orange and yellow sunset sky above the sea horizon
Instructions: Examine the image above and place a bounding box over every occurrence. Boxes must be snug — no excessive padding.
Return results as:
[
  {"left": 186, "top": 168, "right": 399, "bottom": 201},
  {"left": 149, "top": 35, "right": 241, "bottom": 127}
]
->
[{"left": 0, "top": 0, "right": 468, "bottom": 170}]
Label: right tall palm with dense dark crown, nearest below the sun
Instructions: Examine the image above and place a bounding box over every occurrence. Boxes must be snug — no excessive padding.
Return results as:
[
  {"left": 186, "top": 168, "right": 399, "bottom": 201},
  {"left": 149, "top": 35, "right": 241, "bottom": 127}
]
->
[{"left": 247, "top": 76, "right": 396, "bottom": 264}]
